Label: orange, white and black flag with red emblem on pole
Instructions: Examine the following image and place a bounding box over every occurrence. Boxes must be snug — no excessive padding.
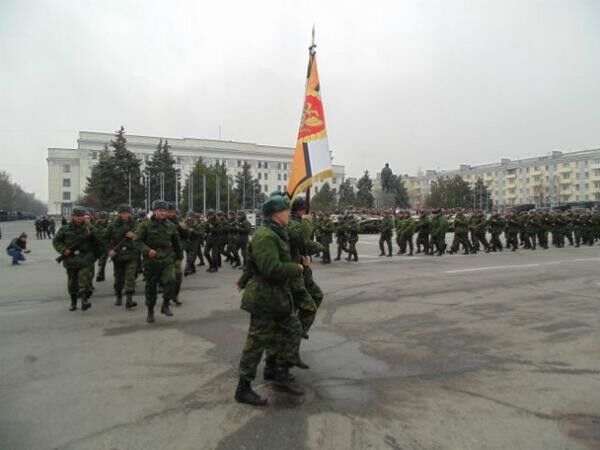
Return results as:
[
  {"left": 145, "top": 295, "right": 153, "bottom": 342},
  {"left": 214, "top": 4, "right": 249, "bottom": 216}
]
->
[{"left": 287, "top": 29, "right": 333, "bottom": 198}]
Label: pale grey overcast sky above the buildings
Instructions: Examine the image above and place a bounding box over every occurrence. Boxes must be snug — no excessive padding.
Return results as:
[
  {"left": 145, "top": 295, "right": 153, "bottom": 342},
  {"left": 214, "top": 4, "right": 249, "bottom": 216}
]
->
[{"left": 0, "top": 0, "right": 600, "bottom": 201}]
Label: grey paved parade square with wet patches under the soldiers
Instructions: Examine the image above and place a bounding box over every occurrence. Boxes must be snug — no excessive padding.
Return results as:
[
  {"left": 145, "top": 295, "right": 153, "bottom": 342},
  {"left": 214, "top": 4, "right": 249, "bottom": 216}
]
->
[{"left": 0, "top": 222, "right": 600, "bottom": 450}]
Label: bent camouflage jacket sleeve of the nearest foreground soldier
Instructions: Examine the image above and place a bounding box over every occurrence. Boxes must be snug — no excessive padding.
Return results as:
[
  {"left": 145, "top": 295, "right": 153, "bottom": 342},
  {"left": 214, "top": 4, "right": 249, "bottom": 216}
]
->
[{"left": 251, "top": 235, "right": 303, "bottom": 282}]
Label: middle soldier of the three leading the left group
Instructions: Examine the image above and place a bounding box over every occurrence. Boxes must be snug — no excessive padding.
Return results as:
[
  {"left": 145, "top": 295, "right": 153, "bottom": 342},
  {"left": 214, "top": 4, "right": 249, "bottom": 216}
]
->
[{"left": 107, "top": 205, "right": 140, "bottom": 310}]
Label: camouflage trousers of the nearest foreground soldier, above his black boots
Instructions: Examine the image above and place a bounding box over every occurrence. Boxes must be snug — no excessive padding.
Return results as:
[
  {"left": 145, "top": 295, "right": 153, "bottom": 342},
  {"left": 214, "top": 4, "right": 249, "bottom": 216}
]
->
[{"left": 239, "top": 314, "right": 302, "bottom": 381}]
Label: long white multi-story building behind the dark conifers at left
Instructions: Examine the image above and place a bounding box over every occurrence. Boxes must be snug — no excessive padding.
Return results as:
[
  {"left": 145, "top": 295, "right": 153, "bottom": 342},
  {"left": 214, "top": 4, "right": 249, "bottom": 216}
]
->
[{"left": 47, "top": 131, "right": 345, "bottom": 215}]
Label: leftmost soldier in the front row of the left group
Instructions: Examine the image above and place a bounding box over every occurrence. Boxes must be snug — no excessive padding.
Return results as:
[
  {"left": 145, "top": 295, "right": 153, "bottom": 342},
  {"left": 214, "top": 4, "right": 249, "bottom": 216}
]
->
[{"left": 52, "top": 207, "right": 100, "bottom": 311}]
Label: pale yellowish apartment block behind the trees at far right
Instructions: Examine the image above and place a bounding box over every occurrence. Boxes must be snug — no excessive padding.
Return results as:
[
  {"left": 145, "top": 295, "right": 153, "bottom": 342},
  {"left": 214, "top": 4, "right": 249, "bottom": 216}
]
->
[{"left": 403, "top": 149, "right": 600, "bottom": 208}]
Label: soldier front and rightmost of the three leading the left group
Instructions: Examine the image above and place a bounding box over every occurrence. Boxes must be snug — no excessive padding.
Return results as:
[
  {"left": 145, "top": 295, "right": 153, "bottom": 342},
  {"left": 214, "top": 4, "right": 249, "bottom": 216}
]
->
[{"left": 133, "top": 200, "right": 183, "bottom": 323}]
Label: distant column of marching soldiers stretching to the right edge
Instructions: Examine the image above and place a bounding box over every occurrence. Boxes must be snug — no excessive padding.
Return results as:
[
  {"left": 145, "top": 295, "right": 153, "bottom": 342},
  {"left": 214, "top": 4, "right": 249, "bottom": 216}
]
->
[{"left": 379, "top": 209, "right": 600, "bottom": 256}]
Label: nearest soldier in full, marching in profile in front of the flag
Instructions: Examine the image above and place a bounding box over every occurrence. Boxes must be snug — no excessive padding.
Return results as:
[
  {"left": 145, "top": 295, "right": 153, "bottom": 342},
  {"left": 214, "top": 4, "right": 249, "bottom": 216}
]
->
[{"left": 235, "top": 195, "right": 309, "bottom": 406}]
